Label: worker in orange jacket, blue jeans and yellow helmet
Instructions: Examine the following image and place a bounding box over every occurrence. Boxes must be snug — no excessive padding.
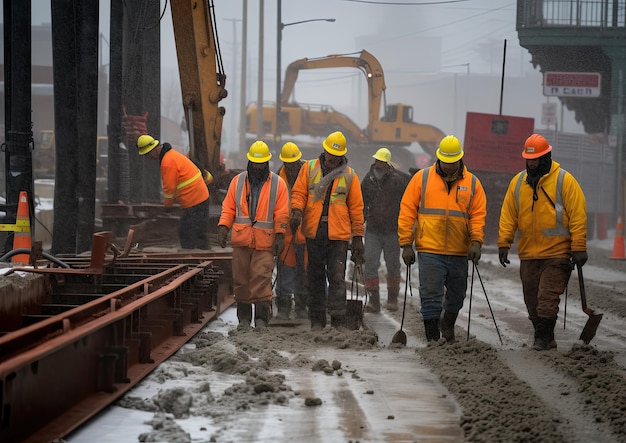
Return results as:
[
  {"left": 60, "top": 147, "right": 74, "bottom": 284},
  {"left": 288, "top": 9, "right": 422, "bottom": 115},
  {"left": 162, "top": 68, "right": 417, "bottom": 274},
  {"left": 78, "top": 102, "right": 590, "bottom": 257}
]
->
[{"left": 398, "top": 135, "right": 487, "bottom": 343}]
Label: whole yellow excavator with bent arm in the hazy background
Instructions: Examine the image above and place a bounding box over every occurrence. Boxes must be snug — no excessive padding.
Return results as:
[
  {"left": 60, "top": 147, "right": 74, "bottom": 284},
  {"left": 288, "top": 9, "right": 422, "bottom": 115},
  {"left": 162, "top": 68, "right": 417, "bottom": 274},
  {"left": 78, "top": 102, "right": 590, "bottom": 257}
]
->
[{"left": 246, "top": 50, "right": 445, "bottom": 172}]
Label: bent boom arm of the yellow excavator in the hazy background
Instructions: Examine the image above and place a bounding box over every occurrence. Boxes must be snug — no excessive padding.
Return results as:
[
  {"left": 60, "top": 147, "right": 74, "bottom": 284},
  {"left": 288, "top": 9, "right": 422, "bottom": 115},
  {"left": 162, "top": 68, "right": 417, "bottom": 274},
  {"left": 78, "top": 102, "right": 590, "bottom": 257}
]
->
[{"left": 280, "top": 50, "right": 387, "bottom": 131}]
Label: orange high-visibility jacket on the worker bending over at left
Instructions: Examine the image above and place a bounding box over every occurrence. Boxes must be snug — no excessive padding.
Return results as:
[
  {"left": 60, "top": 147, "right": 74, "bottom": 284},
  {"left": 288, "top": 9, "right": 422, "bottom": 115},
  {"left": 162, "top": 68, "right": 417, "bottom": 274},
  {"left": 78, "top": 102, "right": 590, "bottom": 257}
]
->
[{"left": 161, "top": 148, "right": 209, "bottom": 208}]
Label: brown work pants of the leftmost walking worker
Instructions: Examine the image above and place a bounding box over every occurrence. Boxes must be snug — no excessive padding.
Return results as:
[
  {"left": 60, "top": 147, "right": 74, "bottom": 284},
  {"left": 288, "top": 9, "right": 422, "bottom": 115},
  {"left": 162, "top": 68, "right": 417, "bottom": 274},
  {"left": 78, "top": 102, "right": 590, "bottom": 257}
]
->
[{"left": 233, "top": 247, "right": 274, "bottom": 303}]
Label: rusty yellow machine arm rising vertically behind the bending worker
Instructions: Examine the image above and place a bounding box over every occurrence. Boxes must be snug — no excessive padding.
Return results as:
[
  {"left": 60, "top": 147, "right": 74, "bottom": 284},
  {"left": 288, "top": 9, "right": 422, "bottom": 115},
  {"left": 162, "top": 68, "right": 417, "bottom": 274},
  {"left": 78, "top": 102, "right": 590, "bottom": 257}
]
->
[{"left": 170, "top": 0, "right": 228, "bottom": 175}]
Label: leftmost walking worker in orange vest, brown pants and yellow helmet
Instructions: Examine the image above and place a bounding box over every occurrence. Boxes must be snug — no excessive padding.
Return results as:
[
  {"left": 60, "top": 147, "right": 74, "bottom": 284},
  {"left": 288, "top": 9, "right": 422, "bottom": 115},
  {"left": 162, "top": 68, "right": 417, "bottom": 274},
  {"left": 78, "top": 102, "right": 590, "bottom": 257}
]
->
[{"left": 217, "top": 140, "right": 289, "bottom": 330}]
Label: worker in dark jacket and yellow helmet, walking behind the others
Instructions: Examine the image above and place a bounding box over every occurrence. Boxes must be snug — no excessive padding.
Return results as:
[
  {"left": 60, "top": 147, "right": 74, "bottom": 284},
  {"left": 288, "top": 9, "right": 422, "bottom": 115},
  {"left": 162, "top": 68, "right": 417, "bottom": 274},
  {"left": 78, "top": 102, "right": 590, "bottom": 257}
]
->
[{"left": 361, "top": 148, "right": 411, "bottom": 312}]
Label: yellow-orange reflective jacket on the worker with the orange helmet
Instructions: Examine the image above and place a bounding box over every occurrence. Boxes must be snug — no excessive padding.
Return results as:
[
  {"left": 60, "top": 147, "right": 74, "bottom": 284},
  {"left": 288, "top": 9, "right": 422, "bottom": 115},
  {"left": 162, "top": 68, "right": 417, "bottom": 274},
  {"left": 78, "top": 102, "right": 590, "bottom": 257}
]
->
[{"left": 498, "top": 161, "right": 587, "bottom": 260}]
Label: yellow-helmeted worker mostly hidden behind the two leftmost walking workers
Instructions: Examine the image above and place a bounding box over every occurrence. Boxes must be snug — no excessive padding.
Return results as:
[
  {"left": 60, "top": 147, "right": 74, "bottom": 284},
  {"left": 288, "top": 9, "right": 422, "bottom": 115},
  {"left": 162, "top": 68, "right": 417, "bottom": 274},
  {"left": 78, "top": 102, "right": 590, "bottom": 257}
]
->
[{"left": 276, "top": 142, "right": 308, "bottom": 320}]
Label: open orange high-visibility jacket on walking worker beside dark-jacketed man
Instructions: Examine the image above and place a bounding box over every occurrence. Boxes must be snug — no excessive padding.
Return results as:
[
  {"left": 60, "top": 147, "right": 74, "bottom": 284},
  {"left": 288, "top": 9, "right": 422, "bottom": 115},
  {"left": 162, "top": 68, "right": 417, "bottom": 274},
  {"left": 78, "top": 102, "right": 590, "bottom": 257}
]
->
[{"left": 291, "top": 158, "right": 365, "bottom": 241}]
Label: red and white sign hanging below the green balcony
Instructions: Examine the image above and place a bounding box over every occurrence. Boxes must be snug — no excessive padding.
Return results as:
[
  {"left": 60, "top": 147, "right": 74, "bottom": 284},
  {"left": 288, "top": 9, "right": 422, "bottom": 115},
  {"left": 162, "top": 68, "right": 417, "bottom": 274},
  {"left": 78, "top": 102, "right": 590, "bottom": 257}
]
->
[{"left": 543, "top": 72, "right": 601, "bottom": 98}]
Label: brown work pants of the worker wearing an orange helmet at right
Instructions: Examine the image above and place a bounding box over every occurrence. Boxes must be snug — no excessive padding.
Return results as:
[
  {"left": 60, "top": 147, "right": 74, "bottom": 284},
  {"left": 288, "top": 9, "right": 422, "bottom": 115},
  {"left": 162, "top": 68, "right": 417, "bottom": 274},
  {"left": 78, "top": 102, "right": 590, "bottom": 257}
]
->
[{"left": 520, "top": 258, "right": 572, "bottom": 320}]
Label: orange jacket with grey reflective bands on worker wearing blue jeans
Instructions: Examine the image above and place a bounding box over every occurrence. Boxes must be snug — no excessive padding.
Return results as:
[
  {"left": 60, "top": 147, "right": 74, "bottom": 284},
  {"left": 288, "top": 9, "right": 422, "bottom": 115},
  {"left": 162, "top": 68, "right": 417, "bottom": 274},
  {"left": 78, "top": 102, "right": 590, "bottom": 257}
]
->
[{"left": 398, "top": 164, "right": 487, "bottom": 256}]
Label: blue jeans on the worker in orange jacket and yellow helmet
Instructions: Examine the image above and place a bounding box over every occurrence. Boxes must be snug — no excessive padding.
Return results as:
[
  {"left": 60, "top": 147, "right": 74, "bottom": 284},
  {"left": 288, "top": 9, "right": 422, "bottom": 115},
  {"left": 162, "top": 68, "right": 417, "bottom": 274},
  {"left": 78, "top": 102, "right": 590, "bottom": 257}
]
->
[{"left": 417, "top": 252, "right": 468, "bottom": 320}]
